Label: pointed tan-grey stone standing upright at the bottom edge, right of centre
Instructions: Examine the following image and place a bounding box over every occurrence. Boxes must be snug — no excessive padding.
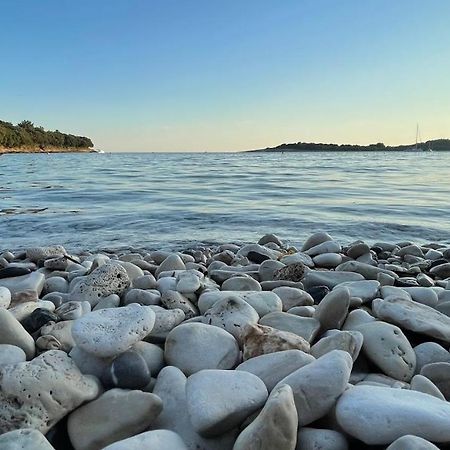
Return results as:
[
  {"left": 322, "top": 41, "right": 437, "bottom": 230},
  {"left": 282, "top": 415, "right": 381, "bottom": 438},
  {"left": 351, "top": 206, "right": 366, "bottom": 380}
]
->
[{"left": 233, "top": 384, "right": 298, "bottom": 450}]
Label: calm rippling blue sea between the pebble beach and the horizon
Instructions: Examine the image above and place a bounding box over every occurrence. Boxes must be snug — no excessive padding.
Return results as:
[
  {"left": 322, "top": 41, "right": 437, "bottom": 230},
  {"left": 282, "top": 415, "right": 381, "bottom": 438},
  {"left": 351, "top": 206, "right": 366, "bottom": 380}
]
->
[{"left": 0, "top": 152, "right": 450, "bottom": 250}]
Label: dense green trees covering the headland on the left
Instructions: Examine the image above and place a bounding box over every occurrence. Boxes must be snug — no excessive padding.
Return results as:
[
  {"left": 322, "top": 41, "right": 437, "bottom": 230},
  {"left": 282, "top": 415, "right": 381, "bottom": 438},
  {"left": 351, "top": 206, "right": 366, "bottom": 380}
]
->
[{"left": 0, "top": 120, "right": 94, "bottom": 149}]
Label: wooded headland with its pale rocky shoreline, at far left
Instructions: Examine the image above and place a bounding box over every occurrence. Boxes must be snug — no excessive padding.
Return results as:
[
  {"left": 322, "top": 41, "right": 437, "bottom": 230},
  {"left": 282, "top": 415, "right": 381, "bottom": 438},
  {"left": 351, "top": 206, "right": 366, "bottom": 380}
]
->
[{"left": 0, "top": 120, "right": 94, "bottom": 154}]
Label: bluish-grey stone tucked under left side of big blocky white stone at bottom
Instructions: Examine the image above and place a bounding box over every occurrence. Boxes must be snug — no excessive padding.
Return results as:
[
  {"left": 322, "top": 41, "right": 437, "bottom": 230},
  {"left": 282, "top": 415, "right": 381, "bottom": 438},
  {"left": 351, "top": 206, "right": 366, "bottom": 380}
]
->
[{"left": 153, "top": 366, "right": 237, "bottom": 450}]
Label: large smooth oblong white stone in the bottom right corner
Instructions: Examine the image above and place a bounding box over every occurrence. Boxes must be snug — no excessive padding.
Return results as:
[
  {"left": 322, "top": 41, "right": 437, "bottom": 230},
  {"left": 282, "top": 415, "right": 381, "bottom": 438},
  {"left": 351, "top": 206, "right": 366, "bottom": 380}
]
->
[{"left": 336, "top": 386, "right": 450, "bottom": 445}]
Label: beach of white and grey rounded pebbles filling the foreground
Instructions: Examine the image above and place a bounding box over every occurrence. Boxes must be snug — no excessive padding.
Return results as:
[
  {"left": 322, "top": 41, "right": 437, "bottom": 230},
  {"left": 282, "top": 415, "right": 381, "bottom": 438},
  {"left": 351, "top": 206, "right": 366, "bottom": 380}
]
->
[{"left": 0, "top": 232, "right": 450, "bottom": 450}]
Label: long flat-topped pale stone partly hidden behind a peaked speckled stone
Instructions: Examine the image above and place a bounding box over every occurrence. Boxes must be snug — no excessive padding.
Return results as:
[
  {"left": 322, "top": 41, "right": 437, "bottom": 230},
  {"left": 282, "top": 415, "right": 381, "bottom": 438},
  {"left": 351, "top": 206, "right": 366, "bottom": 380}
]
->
[{"left": 198, "top": 291, "right": 282, "bottom": 317}]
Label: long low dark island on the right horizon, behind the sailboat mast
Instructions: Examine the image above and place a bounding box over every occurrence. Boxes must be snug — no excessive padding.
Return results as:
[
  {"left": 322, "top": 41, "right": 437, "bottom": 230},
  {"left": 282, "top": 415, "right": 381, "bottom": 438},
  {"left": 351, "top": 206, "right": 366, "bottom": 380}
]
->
[{"left": 249, "top": 139, "right": 450, "bottom": 152}]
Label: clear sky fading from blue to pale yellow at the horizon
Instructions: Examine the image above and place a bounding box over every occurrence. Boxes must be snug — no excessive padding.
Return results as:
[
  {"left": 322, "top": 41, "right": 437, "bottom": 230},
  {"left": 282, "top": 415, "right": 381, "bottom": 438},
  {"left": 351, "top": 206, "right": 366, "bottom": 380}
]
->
[{"left": 0, "top": 0, "right": 450, "bottom": 151}]
